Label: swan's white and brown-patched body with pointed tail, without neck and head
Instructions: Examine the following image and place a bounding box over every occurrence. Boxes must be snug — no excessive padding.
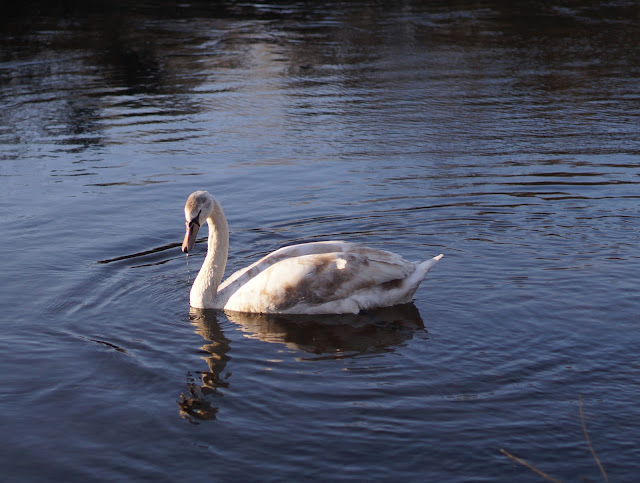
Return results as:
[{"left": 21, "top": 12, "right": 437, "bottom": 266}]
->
[{"left": 216, "top": 241, "right": 440, "bottom": 313}]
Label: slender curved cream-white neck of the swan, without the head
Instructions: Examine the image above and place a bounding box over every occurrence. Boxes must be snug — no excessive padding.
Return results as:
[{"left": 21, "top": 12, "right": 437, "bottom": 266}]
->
[{"left": 190, "top": 201, "right": 229, "bottom": 309}]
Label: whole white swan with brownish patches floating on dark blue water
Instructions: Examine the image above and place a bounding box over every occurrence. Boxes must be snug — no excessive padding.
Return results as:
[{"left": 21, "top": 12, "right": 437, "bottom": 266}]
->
[{"left": 182, "top": 191, "right": 442, "bottom": 314}]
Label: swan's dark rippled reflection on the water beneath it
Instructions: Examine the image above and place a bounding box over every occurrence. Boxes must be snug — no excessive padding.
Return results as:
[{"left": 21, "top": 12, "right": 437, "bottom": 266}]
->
[{"left": 177, "top": 304, "right": 425, "bottom": 424}]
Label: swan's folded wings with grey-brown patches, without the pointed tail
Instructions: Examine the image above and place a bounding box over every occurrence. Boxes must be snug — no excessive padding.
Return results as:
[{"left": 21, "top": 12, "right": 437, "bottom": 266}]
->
[{"left": 218, "top": 243, "right": 415, "bottom": 313}]
